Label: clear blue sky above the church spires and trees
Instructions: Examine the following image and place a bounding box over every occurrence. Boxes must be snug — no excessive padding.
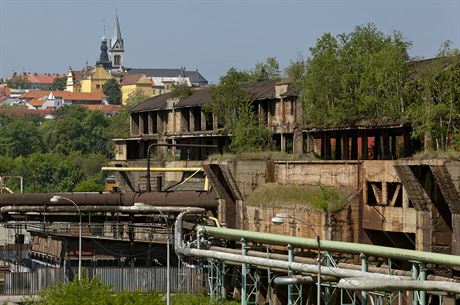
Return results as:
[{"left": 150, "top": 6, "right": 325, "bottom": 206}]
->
[{"left": 0, "top": 0, "right": 460, "bottom": 82}]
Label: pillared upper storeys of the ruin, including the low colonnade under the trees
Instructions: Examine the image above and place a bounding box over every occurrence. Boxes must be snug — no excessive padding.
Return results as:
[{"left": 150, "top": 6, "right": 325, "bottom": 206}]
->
[{"left": 114, "top": 80, "right": 417, "bottom": 160}]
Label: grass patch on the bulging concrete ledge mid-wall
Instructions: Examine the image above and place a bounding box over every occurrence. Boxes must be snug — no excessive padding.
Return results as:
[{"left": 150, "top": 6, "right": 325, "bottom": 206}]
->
[{"left": 246, "top": 183, "right": 348, "bottom": 212}]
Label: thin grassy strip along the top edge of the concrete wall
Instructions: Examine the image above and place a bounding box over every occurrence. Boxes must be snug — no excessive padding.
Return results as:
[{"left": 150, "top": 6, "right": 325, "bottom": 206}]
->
[{"left": 208, "top": 151, "right": 318, "bottom": 161}]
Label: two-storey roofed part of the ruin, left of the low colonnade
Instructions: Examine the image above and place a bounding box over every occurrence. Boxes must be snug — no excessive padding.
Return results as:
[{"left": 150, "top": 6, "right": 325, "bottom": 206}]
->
[{"left": 115, "top": 81, "right": 302, "bottom": 160}]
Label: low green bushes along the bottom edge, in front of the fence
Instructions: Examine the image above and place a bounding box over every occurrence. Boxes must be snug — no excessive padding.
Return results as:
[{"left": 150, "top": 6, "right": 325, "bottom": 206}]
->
[{"left": 25, "top": 277, "right": 239, "bottom": 305}]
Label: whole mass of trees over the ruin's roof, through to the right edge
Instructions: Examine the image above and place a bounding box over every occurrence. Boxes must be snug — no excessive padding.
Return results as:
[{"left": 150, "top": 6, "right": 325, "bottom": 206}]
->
[{"left": 292, "top": 24, "right": 460, "bottom": 150}]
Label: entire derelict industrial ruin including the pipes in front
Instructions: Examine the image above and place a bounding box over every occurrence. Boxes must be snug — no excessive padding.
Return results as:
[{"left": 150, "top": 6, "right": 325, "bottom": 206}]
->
[{"left": 0, "top": 57, "right": 460, "bottom": 305}]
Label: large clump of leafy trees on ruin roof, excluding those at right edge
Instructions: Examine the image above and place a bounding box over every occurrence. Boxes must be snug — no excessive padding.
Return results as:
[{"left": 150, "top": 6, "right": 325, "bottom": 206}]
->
[{"left": 301, "top": 24, "right": 410, "bottom": 126}]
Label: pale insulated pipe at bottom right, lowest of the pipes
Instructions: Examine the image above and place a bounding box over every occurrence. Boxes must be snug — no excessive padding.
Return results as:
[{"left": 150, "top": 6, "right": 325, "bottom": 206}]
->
[{"left": 337, "top": 278, "right": 460, "bottom": 294}]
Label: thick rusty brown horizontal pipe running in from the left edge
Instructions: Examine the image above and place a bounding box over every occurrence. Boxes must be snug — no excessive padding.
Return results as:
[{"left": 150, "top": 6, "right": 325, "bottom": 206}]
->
[{"left": 0, "top": 191, "right": 218, "bottom": 209}]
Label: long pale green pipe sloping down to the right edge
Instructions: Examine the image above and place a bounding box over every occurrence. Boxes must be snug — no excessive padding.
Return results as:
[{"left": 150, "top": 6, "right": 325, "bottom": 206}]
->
[{"left": 198, "top": 226, "right": 460, "bottom": 266}]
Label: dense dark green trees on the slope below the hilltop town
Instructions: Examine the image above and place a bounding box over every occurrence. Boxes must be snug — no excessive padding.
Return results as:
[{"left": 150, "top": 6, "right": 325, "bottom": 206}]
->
[{"left": 0, "top": 106, "right": 120, "bottom": 192}]
